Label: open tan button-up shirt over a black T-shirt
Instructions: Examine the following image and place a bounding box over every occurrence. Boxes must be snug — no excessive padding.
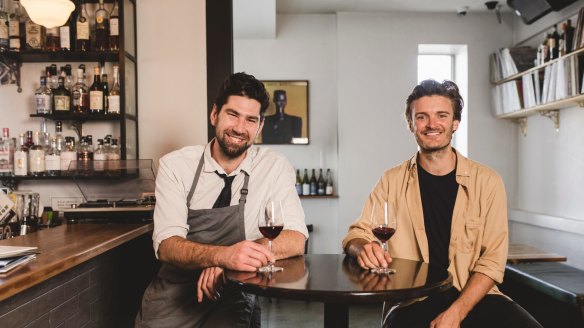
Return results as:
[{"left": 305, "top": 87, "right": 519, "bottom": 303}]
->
[{"left": 343, "top": 152, "right": 509, "bottom": 294}]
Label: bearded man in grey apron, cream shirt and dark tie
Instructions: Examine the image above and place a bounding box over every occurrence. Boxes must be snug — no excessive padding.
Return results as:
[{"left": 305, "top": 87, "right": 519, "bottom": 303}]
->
[{"left": 136, "top": 73, "right": 308, "bottom": 327}]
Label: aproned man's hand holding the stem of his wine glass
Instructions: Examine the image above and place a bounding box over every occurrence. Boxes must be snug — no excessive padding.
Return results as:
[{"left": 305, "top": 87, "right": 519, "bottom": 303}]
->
[{"left": 218, "top": 240, "right": 276, "bottom": 271}]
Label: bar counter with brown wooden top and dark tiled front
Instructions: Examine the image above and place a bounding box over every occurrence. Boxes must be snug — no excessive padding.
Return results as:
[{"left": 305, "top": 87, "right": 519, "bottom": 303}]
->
[{"left": 0, "top": 223, "right": 157, "bottom": 327}]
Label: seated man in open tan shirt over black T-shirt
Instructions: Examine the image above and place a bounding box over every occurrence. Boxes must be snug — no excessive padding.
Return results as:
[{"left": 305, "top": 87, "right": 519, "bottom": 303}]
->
[{"left": 343, "top": 80, "right": 541, "bottom": 328}]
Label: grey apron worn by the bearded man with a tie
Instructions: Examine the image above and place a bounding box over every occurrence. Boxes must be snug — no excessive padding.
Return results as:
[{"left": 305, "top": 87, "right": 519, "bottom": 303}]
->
[{"left": 136, "top": 155, "right": 259, "bottom": 328}]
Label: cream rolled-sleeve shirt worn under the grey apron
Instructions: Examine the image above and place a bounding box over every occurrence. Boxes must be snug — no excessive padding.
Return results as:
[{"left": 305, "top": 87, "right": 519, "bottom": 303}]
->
[{"left": 152, "top": 139, "right": 308, "bottom": 256}]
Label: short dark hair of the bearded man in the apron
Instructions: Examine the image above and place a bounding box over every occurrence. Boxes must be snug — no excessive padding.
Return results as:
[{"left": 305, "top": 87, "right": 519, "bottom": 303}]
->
[{"left": 214, "top": 72, "right": 270, "bottom": 119}]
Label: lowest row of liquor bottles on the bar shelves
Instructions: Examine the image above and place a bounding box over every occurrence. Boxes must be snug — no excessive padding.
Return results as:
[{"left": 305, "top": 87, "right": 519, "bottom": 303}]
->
[{"left": 0, "top": 121, "right": 121, "bottom": 177}]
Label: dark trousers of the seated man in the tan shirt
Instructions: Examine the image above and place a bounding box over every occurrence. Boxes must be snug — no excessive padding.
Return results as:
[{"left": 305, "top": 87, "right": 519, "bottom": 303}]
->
[{"left": 384, "top": 288, "right": 542, "bottom": 328}]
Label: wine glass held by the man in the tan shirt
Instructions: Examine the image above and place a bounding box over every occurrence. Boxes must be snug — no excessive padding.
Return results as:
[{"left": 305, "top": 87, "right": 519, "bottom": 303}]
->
[{"left": 371, "top": 202, "right": 397, "bottom": 274}]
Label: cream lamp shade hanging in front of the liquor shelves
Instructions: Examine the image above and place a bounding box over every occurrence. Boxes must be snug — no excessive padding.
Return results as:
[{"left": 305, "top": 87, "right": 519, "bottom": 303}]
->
[{"left": 20, "top": 0, "right": 75, "bottom": 28}]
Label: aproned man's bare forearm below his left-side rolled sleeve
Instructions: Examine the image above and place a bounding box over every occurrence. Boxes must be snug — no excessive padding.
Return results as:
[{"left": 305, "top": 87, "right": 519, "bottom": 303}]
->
[{"left": 158, "top": 236, "right": 222, "bottom": 270}]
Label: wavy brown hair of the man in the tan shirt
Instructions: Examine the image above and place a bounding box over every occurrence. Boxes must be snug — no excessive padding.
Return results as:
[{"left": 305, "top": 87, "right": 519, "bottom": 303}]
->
[{"left": 405, "top": 79, "right": 464, "bottom": 130}]
